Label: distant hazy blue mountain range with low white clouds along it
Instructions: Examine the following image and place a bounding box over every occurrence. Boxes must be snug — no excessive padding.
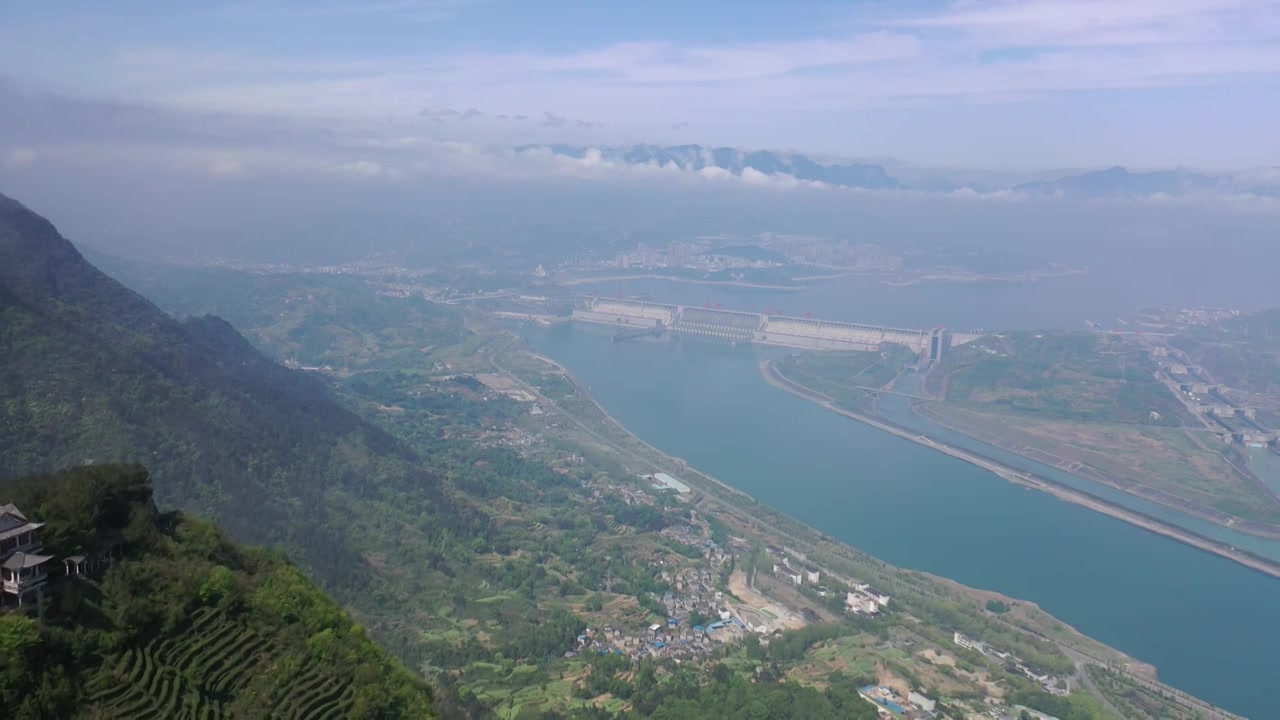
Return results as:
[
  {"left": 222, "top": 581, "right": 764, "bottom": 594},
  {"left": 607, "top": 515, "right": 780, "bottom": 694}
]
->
[{"left": 527, "top": 145, "right": 1280, "bottom": 197}]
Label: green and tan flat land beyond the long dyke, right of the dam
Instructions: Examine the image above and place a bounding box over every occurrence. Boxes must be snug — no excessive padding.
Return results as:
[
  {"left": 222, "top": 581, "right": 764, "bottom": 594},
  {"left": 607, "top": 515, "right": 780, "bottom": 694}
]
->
[{"left": 927, "top": 332, "right": 1280, "bottom": 523}]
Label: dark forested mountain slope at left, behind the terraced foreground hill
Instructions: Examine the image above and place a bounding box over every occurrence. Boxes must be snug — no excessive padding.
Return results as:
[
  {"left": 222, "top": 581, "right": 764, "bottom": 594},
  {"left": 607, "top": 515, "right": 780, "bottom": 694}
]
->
[{"left": 0, "top": 196, "right": 458, "bottom": 585}]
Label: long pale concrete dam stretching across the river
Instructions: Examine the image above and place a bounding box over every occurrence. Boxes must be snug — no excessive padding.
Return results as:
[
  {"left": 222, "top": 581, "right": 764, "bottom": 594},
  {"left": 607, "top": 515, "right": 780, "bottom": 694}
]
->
[{"left": 572, "top": 296, "right": 980, "bottom": 360}]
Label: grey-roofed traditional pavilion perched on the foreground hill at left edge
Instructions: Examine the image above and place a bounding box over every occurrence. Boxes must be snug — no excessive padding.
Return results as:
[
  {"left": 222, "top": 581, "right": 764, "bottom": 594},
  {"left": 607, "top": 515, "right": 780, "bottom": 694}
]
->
[{"left": 0, "top": 502, "right": 111, "bottom": 607}]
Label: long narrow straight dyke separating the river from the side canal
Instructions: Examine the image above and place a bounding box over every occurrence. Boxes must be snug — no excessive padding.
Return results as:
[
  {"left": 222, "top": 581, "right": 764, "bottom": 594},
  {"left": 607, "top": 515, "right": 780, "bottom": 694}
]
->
[{"left": 760, "top": 360, "right": 1280, "bottom": 578}]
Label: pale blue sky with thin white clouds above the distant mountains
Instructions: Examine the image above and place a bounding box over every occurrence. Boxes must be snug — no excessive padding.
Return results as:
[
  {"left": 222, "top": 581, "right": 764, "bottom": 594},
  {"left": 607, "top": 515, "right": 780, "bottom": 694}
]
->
[{"left": 0, "top": 0, "right": 1280, "bottom": 170}]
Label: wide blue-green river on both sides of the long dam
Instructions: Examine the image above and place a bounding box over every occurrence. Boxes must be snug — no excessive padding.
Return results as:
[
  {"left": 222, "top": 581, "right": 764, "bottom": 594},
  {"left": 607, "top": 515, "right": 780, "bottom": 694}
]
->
[{"left": 525, "top": 275, "right": 1280, "bottom": 719}]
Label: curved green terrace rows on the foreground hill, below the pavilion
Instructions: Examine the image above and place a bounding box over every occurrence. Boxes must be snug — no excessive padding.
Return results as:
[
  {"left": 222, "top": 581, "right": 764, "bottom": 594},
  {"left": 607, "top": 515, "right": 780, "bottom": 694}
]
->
[{"left": 86, "top": 609, "right": 353, "bottom": 720}]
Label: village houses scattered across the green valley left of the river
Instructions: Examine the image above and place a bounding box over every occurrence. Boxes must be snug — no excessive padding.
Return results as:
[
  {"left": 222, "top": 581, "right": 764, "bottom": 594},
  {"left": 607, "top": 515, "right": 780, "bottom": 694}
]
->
[{"left": 337, "top": 353, "right": 1121, "bottom": 720}]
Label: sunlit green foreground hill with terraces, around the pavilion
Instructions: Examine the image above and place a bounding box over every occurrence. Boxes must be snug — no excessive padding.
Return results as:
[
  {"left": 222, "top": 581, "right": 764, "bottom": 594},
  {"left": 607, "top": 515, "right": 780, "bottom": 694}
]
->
[{"left": 0, "top": 465, "right": 431, "bottom": 719}]
